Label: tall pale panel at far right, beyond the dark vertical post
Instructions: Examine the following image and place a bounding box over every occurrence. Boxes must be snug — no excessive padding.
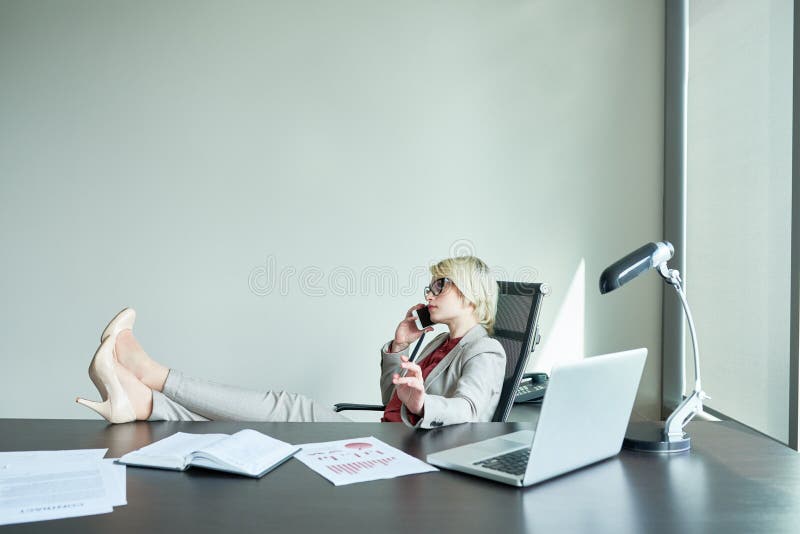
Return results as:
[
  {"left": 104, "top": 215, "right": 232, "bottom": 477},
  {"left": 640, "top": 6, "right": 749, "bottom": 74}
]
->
[{"left": 686, "top": 0, "right": 793, "bottom": 442}]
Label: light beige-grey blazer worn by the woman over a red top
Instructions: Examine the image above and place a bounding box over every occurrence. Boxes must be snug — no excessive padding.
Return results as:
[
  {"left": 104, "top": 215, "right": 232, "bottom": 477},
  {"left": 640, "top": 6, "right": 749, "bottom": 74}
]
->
[{"left": 381, "top": 325, "right": 506, "bottom": 428}]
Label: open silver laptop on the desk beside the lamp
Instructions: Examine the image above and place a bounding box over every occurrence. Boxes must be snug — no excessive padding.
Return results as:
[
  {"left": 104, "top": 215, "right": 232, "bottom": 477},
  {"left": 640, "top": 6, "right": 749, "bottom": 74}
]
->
[{"left": 428, "top": 349, "right": 647, "bottom": 486}]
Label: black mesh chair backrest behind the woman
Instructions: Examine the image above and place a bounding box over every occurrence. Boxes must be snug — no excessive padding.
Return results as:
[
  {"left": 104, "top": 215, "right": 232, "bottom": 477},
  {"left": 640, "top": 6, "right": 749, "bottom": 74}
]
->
[{"left": 492, "top": 282, "right": 550, "bottom": 422}]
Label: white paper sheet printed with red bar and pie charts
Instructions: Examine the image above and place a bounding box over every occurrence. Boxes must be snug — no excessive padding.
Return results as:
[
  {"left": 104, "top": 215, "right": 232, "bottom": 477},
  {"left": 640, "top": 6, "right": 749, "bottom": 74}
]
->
[{"left": 295, "top": 436, "right": 438, "bottom": 486}]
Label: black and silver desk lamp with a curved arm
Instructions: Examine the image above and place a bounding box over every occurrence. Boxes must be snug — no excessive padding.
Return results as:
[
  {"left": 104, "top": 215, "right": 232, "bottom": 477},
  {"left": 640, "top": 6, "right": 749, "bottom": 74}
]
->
[{"left": 600, "top": 241, "right": 709, "bottom": 453}]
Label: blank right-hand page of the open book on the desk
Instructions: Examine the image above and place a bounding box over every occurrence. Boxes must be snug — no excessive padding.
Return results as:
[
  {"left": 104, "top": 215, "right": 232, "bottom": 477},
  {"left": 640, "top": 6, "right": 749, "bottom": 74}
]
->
[{"left": 190, "top": 429, "right": 297, "bottom": 476}]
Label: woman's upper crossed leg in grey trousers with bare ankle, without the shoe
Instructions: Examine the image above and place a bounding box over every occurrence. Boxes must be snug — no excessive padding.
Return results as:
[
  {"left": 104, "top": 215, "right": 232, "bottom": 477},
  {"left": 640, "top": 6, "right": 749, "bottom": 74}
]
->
[{"left": 115, "top": 330, "right": 350, "bottom": 422}]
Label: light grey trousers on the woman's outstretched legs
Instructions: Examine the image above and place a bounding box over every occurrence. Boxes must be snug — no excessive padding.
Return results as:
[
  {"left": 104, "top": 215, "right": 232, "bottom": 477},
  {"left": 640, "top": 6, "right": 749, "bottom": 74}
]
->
[{"left": 148, "top": 369, "right": 350, "bottom": 423}]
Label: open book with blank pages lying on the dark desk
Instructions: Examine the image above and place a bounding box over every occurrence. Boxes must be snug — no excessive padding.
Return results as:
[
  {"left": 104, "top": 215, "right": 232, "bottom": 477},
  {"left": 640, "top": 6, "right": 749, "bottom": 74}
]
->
[{"left": 117, "top": 429, "right": 300, "bottom": 478}]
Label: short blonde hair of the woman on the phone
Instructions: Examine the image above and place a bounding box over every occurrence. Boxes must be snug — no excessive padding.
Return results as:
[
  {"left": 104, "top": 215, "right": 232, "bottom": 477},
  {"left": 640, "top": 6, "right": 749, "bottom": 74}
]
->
[{"left": 431, "top": 256, "right": 497, "bottom": 334}]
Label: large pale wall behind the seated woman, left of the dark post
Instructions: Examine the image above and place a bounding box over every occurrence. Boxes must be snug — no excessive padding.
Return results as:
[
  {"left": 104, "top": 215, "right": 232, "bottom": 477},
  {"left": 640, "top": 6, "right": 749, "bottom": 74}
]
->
[{"left": 0, "top": 0, "right": 664, "bottom": 418}]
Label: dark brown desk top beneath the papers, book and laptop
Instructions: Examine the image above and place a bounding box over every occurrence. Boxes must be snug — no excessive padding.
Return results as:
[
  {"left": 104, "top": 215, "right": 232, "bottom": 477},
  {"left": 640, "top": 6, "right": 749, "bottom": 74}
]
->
[{"left": 0, "top": 419, "right": 800, "bottom": 534}]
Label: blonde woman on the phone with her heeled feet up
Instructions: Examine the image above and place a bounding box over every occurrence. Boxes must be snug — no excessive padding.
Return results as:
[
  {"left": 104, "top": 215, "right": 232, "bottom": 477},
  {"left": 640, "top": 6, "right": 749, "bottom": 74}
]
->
[{"left": 76, "top": 256, "right": 505, "bottom": 428}]
